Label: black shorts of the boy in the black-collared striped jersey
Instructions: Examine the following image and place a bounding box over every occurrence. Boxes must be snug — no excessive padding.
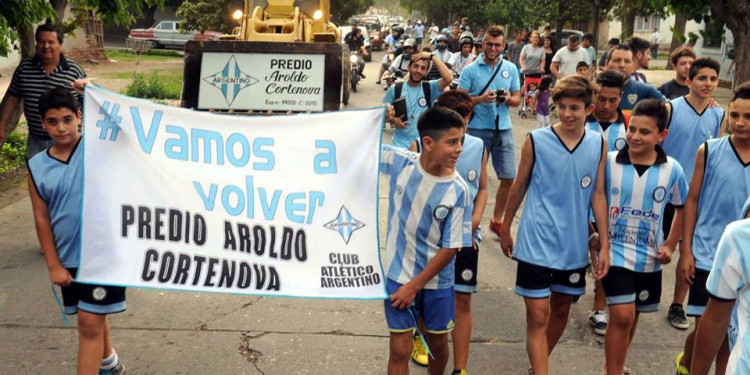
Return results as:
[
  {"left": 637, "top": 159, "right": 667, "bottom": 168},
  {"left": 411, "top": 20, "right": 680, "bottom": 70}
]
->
[{"left": 602, "top": 267, "right": 661, "bottom": 312}]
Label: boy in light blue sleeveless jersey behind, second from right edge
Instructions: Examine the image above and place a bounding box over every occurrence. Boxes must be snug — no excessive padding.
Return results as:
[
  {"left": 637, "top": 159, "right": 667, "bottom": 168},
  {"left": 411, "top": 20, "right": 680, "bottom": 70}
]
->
[{"left": 662, "top": 57, "right": 724, "bottom": 329}]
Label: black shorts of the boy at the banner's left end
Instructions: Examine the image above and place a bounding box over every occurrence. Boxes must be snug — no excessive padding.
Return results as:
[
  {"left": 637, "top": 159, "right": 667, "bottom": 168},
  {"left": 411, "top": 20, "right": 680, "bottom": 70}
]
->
[{"left": 60, "top": 268, "right": 125, "bottom": 315}]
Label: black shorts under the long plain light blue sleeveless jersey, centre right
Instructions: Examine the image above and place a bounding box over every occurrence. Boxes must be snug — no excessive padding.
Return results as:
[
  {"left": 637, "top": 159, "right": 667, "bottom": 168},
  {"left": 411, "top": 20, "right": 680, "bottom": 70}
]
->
[{"left": 516, "top": 260, "right": 586, "bottom": 299}]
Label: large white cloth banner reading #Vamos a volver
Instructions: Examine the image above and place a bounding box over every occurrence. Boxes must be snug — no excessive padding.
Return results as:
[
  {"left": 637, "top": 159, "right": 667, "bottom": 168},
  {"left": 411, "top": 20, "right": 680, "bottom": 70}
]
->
[{"left": 78, "top": 87, "right": 386, "bottom": 299}]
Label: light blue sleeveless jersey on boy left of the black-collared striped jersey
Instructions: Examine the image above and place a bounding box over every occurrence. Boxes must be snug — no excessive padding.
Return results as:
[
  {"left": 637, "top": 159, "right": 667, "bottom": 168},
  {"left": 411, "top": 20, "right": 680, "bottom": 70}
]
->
[{"left": 513, "top": 127, "right": 604, "bottom": 270}]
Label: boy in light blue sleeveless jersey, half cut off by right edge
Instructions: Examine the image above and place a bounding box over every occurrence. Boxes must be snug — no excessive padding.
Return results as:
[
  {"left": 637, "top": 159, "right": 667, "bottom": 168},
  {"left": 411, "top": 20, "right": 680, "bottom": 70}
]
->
[{"left": 675, "top": 82, "right": 750, "bottom": 374}]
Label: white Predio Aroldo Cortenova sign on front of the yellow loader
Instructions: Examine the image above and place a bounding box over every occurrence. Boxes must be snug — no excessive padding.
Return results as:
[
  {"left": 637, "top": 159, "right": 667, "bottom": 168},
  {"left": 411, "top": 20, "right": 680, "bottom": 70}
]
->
[{"left": 198, "top": 52, "right": 325, "bottom": 112}]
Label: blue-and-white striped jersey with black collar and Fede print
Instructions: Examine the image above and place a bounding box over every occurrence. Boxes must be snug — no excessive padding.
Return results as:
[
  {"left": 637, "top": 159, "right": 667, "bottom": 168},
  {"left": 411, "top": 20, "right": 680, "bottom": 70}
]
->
[{"left": 606, "top": 146, "right": 688, "bottom": 272}]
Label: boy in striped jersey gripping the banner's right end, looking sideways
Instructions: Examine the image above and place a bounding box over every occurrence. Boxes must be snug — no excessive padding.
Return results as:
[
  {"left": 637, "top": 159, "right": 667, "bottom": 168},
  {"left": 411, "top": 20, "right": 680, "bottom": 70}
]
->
[{"left": 380, "top": 107, "right": 472, "bottom": 374}]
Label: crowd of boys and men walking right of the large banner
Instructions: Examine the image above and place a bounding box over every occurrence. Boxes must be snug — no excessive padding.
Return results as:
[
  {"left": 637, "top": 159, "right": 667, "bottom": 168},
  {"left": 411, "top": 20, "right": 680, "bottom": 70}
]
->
[{"left": 384, "top": 19, "right": 750, "bottom": 375}]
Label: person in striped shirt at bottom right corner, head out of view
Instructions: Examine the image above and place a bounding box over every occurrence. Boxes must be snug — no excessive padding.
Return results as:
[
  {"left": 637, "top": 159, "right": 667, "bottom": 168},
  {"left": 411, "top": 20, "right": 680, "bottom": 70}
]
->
[{"left": 690, "top": 195, "right": 750, "bottom": 375}]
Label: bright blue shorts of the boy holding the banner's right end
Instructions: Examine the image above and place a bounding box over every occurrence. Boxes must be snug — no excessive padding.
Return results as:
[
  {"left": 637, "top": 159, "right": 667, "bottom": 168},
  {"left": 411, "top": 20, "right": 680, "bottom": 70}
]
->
[{"left": 385, "top": 279, "right": 455, "bottom": 334}]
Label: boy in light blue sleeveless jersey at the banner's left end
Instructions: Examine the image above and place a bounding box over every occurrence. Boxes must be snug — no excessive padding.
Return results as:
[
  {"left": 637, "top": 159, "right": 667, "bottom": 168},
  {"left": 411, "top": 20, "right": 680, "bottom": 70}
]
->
[{"left": 28, "top": 88, "right": 125, "bottom": 375}]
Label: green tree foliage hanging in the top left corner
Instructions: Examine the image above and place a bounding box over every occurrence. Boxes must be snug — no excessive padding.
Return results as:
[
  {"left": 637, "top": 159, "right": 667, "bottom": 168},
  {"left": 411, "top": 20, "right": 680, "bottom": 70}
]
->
[{"left": 0, "top": 0, "right": 165, "bottom": 57}]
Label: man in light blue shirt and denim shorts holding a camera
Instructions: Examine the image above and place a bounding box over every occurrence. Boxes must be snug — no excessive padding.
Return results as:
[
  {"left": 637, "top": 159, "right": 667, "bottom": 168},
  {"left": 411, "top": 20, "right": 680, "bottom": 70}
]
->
[{"left": 458, "top": 26, "right": 521, "bottom": 236}]
